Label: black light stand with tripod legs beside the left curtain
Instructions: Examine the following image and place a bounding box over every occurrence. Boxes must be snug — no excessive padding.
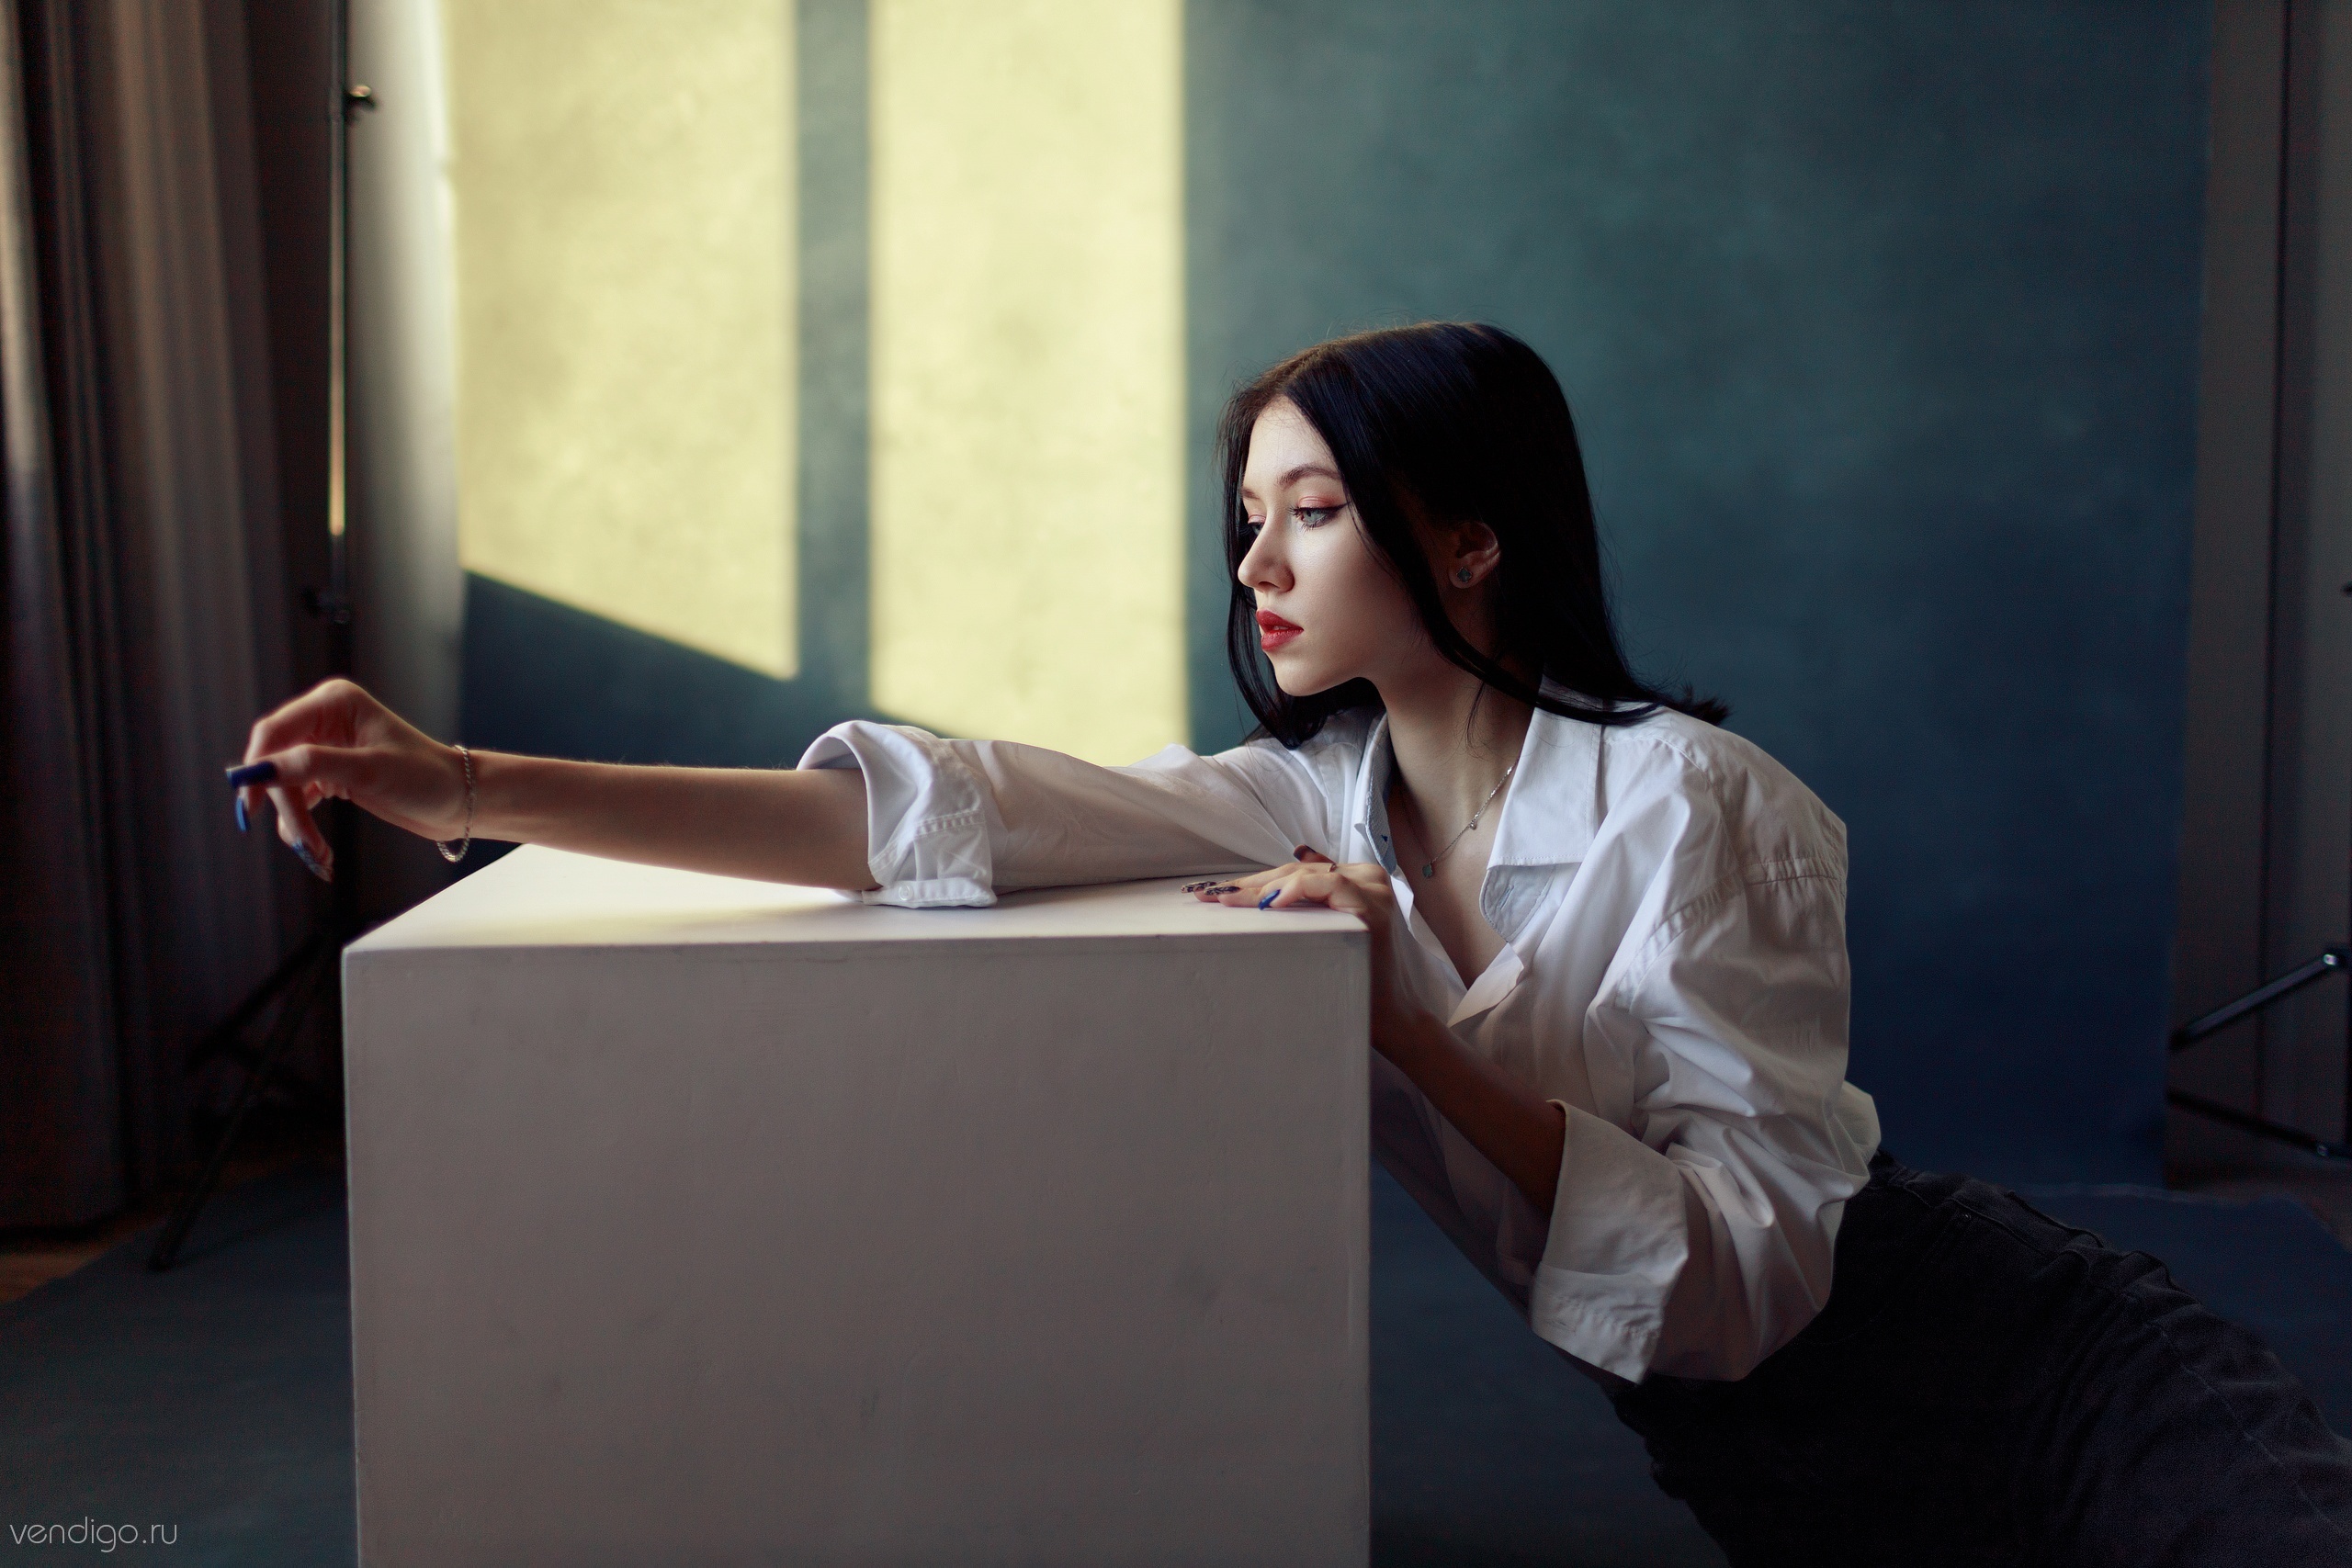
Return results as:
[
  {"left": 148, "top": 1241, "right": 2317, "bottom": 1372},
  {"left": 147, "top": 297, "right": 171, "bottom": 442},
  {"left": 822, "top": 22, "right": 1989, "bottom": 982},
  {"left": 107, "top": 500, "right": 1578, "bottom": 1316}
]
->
[{"left": 148, "top": 0, "right": 377, "bottom": 1272}]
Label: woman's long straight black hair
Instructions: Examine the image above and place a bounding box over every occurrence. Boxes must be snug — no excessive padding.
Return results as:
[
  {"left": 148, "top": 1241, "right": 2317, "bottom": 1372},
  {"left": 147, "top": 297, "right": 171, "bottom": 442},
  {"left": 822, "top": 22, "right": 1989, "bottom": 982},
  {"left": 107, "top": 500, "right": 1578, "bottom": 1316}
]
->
[{"left": 1218, "top": 322, "right": 1729, "bottom": 745}]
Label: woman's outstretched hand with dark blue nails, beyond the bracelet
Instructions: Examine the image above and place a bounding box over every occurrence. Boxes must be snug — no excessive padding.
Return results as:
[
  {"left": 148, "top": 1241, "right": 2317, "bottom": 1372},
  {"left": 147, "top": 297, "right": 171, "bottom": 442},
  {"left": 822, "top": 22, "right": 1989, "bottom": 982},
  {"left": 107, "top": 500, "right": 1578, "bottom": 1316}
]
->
[{"left": 238, "top": 680, "right": 466, "bottom": 877}]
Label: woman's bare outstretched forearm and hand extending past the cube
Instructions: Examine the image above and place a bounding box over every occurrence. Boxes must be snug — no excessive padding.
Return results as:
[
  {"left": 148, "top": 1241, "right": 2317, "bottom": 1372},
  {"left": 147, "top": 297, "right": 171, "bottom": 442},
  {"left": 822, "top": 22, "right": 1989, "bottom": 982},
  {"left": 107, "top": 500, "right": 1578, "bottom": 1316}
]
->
[{"left": 244, "top": 680, "right": 873, "bottom": 888}]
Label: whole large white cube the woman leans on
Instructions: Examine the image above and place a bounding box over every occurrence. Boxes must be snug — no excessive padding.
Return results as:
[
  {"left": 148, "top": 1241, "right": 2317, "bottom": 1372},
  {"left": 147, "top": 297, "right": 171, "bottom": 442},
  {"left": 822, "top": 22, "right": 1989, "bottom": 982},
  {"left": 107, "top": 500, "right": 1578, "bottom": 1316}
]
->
[{"left": 344, "top": 849, "right": 1371, "bottom": 1568}]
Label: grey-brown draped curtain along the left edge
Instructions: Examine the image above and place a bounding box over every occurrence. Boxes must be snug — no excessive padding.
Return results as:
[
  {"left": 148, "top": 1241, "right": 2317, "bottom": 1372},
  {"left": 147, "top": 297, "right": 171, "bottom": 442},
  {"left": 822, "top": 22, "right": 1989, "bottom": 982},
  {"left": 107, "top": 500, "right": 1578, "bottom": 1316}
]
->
[{"left": 0, "top": 0, "right": 322, "bottom": 1227}]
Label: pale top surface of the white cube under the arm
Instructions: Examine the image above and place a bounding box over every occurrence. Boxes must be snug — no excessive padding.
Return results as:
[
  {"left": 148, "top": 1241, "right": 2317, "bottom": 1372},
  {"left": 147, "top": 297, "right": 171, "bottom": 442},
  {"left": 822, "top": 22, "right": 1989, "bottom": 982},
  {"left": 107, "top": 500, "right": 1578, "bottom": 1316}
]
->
[{"left": 350, "top": 844, "right": 1364, "bottom": 952}]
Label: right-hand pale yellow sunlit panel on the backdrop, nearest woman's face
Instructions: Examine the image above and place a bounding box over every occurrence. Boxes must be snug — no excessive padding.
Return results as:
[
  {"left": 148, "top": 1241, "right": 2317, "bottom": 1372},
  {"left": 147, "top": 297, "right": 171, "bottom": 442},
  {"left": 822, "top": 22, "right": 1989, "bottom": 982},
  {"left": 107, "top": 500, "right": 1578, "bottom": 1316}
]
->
[{"left": 873, "top": 0, "right": 1185, "bottom": 761}]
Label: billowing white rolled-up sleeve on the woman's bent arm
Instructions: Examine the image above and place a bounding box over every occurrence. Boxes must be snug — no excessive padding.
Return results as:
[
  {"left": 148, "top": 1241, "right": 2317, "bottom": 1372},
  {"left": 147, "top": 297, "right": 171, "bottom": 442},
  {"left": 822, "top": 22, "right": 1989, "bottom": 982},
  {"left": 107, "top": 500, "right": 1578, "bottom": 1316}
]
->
[{"left": 1529, "top": 858, "right": 1877, "bottom": 1380}]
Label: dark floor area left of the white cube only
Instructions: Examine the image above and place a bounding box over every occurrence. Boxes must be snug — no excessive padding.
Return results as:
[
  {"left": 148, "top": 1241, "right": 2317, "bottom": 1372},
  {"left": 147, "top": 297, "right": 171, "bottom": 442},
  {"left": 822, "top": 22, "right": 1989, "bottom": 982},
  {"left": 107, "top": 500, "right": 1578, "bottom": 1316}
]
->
[{"left": 0, "top": 1168, "right": 356, "bottom": 1568}]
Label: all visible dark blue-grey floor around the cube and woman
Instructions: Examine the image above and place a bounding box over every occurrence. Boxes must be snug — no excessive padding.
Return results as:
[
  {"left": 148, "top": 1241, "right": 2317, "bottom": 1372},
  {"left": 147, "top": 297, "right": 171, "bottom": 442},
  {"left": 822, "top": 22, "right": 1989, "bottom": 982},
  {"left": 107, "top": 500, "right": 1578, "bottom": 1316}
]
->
[{"left": 0, "top": 1168, "right": 2352, "bottom": 1568}]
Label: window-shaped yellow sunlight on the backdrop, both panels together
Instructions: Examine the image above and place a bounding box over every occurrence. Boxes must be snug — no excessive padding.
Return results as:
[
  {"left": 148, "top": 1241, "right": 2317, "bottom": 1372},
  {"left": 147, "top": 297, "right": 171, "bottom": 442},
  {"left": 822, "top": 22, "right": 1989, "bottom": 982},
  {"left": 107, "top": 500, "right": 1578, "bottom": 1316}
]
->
[{"left": 440, "top": 0, "right": 1188, "bottom": 761}]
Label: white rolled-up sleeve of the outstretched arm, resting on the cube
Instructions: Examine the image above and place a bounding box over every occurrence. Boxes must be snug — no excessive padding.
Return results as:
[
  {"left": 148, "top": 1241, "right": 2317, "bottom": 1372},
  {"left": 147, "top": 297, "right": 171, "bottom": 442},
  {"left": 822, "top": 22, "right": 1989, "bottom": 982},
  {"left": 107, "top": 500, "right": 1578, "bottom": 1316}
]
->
[{"left": 799, "top": 722, "right": 1331, "bottom": 908}]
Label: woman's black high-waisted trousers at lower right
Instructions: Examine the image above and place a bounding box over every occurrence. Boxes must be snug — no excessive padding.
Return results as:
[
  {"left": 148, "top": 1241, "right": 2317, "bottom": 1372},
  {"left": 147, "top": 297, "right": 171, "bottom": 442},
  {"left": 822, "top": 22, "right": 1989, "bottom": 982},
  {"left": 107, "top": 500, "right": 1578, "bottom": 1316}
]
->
[{"left": 1616, "top": 1152, "right": 2352, "bottom": 1568}]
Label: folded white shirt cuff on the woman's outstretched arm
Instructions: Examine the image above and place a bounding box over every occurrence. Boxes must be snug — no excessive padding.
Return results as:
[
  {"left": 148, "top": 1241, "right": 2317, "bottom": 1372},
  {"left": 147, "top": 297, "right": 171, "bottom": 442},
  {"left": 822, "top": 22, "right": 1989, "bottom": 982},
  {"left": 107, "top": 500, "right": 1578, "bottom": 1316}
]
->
[{"left": 799, "top": 719, "right": 997, "bottom": 909}]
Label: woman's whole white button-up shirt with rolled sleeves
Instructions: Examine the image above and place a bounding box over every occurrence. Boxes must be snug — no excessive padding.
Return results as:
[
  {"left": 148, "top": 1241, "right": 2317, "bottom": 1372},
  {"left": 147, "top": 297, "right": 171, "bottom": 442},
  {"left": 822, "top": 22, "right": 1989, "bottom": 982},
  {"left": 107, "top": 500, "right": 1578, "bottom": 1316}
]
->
[{"left": 802, "top": 710, "right": 1879, "bottom": 1380}]
